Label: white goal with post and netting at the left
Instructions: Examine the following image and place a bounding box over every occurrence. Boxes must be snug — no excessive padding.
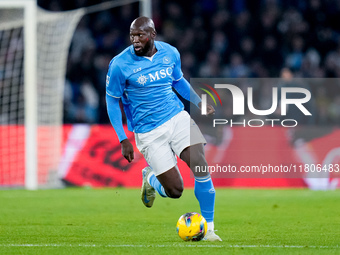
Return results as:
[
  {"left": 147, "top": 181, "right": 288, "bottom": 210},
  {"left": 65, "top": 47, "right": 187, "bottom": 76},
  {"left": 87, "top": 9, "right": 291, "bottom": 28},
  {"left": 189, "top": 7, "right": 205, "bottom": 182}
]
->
[{"left": 0, "top": 0, "right": 150, "bottom": 189}]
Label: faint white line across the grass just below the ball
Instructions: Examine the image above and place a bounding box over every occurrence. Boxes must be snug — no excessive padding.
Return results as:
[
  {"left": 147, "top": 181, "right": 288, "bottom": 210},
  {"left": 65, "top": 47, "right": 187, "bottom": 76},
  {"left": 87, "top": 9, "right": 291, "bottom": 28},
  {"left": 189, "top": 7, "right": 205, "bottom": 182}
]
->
[{"left": 0, "top": 244, "right": 340, "bottom": 249}]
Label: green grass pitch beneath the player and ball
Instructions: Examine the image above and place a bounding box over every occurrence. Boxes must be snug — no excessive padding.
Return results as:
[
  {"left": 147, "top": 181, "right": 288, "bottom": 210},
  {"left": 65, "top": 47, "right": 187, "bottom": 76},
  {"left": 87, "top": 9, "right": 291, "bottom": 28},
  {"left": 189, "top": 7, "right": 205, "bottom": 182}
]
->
[{"left": 0, "top": 188, "right": 340, "bottom": 255}]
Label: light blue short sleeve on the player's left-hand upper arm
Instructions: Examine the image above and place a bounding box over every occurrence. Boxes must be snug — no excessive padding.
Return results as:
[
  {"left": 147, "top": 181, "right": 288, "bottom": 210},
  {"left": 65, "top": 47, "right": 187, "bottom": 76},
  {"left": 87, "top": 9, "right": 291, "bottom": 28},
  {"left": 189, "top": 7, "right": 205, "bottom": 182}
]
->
[{"left": 106, "top": 60, "right": 126, "bottom": 98}]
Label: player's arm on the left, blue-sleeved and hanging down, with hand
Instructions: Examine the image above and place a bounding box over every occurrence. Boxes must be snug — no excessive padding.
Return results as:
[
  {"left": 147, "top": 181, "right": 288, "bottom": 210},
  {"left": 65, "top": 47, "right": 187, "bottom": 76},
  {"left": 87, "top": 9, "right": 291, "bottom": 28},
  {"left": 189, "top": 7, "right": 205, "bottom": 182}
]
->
[{"left": 106, "top": 61, "right": 134, "bottom": 162}]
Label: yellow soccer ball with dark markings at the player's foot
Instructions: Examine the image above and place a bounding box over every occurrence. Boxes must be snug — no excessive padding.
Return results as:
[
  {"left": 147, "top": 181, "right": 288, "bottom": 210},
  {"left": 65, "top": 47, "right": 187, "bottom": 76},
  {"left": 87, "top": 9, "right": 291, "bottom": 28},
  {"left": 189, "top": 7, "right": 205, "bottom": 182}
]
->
[{"left": 176, "top": 212, "right": 208, "bottom": 241}]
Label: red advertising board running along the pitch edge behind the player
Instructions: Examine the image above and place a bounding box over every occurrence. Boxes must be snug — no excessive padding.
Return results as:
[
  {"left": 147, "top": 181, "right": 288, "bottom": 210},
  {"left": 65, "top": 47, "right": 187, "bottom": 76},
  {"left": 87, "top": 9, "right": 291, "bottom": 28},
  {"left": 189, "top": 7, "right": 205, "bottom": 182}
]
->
[{"left": 0, "top": 125, "right": 340, "bottom": 189}]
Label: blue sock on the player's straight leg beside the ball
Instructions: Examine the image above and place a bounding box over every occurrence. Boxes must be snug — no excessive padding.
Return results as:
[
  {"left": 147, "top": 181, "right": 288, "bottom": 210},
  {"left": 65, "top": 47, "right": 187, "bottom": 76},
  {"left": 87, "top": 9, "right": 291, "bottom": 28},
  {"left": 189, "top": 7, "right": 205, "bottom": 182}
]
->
[{"left": 195, "top": 175, "right": 215, "bottom": 222}]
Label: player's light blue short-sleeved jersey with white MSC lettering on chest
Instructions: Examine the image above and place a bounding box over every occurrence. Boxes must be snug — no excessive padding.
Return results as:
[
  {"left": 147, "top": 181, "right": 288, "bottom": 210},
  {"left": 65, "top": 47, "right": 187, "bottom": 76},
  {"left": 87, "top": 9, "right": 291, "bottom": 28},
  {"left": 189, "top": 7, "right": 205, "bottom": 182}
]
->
[{"left": 106, "top": 41, "right": 184, "bottom": 133}]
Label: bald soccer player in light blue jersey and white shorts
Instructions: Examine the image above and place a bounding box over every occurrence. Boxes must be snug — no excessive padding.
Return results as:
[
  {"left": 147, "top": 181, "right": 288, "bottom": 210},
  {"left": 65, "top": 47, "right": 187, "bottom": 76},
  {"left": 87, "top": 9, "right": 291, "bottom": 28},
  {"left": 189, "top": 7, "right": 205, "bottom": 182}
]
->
[{"left": 106, "top": 17, "right": 222, "bottom": 241}]
